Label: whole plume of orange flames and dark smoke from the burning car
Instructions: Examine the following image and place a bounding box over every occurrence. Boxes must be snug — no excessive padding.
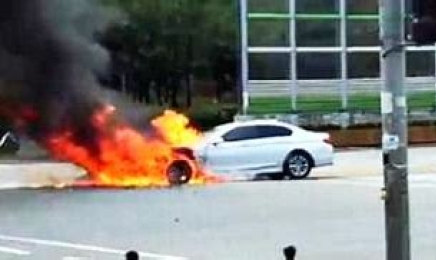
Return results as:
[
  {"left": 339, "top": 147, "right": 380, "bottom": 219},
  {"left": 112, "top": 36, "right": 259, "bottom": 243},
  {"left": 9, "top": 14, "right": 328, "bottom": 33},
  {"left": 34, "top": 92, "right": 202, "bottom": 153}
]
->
[{"left": 0, "top": 0, "right": 221, "bottom": 190}]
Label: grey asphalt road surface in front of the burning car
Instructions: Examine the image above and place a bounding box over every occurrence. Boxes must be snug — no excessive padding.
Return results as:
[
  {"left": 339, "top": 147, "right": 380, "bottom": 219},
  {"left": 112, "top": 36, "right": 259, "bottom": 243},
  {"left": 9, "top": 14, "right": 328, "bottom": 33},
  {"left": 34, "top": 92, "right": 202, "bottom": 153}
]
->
[{"left": 0, "top": 174, "right": 436, "bottom": 260}]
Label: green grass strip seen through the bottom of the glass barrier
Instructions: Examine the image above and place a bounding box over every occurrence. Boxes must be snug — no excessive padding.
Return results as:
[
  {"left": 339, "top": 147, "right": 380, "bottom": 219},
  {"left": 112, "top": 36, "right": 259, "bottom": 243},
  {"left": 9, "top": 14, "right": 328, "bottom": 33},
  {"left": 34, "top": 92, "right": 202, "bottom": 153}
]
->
[{"left": 248, "top": 92, "right": 435, "bottom": 114}]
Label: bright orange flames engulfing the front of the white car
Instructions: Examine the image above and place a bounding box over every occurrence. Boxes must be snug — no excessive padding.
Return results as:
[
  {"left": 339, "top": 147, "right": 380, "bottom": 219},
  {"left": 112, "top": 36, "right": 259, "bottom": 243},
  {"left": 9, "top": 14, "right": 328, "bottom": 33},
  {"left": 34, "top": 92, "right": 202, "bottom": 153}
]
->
[{"left": 40, "top": 106, "right": 216, "bottom": 187}]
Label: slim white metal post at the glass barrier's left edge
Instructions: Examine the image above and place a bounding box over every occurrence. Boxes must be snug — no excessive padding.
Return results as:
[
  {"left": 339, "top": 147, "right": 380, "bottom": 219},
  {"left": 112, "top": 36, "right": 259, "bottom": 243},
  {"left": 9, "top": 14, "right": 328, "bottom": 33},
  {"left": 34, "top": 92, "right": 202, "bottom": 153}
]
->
[{"left": 239, "top": 0, "right": 249, "bottom": 115}]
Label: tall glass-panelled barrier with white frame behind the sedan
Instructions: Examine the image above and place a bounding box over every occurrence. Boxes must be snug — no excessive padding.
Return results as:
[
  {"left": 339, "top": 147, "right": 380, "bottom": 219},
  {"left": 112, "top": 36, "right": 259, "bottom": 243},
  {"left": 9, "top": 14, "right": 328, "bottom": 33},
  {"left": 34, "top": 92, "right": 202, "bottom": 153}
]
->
[{"left": 241, "top": 0, "right": 436, "bottom": 113}]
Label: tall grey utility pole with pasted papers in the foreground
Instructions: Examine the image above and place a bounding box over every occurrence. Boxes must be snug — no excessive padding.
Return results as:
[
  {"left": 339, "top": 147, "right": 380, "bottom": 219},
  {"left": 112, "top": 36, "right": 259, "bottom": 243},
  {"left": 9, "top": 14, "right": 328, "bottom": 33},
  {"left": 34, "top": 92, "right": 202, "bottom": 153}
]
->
[{"left": 380, "top": 0, "right": 410, "bottom": 260}]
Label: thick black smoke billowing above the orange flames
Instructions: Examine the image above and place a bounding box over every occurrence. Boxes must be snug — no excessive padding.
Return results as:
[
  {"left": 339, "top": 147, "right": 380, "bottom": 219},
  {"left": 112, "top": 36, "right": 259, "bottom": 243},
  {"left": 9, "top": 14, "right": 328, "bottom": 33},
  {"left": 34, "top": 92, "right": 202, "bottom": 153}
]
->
[{"left": 0, "top": 0, "right": 116, "bottom": 153}]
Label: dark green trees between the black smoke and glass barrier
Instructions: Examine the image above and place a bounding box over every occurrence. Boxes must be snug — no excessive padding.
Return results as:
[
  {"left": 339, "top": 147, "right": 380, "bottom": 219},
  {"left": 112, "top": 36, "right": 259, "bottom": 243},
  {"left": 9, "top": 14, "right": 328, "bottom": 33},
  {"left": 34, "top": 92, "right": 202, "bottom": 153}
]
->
[{"left": 99, "top": 0, "right": 238, "bottom": 106}]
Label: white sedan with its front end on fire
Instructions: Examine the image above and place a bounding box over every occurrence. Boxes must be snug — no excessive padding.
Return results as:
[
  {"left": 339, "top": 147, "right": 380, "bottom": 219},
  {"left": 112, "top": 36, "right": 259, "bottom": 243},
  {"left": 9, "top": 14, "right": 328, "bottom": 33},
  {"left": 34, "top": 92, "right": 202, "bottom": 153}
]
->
[{"left": 172, "top": 120, "right": 334, "bottom": 182}]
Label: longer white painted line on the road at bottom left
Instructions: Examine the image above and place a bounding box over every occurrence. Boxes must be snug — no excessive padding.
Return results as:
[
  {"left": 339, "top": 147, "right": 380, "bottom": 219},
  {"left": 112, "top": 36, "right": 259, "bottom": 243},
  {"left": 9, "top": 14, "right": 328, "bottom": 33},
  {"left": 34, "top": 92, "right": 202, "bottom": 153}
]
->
[{"left": 0, "top": 235, "right": 188, "bottom": 260}]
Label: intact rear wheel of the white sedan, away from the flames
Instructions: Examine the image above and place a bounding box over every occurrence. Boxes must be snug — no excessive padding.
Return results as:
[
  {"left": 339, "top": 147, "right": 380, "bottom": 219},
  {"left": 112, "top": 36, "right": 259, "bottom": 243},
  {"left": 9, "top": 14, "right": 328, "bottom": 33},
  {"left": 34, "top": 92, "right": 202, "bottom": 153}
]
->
[{"left": 283, "top": 151, "right": 313, "bottom": 179}]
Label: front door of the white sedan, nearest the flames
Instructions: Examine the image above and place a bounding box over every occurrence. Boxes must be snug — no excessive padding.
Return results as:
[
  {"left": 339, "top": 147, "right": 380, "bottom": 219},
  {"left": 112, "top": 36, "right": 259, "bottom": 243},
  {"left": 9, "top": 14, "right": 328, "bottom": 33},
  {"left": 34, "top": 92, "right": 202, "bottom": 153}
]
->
[{"left": 205, "top": 126, "right": 259, "bottom": 173}]
